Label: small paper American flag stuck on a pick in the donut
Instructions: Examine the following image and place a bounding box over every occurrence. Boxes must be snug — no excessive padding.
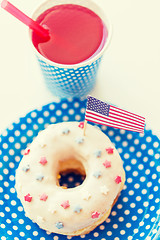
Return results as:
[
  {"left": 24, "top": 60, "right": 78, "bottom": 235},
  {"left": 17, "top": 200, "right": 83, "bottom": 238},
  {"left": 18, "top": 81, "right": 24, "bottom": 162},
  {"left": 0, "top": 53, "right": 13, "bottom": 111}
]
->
[{"left": 85, "top": 96, "right": 145, "bottom": 133}]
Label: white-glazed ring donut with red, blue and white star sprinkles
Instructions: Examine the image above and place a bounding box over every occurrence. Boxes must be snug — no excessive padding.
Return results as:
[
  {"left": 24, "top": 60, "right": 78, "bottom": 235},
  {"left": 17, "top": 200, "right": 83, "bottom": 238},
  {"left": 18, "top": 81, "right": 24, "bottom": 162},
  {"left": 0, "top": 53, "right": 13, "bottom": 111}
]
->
[{"left": 15, "top": 122, "right": 125, "bottom": 236}]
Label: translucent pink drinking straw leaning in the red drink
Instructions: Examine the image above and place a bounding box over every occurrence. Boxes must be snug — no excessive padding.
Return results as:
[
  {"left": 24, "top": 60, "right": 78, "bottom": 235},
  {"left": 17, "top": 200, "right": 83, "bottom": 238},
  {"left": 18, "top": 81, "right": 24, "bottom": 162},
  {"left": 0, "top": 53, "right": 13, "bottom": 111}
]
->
[{"left": 1, "top": 0, "right": 49, "bottom": 40}]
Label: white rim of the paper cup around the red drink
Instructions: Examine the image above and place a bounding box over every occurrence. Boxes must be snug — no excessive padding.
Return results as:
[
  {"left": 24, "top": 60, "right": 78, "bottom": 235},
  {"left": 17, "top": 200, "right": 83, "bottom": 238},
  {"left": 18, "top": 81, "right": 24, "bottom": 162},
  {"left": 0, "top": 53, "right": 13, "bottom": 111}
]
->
[{"left": 29, "top": 0, "right": 112, "bottom": 69}]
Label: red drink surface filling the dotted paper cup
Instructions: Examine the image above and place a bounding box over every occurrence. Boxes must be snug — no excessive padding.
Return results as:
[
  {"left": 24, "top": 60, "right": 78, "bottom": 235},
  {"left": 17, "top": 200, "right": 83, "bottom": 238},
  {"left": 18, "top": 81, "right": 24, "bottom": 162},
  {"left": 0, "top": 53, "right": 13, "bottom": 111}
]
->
[{"left": 32, "top": 4, "right": 105, "bottom": 64}]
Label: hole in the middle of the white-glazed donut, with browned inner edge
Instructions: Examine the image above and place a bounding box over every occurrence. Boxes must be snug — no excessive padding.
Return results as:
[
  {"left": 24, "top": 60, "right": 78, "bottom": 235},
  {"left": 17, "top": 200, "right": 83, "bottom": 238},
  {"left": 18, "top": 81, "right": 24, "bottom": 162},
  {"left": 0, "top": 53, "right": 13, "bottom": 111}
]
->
[{"left": 57, "top": 159, "right": 86, "bottom": 188}]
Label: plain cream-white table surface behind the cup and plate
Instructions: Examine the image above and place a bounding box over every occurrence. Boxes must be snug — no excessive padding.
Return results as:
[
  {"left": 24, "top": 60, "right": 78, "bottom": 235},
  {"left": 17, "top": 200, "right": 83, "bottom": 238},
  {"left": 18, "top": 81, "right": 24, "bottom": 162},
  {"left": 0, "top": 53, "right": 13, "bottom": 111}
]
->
[{"left": 0, "top": 0, "right": 160, "bottom": 138}]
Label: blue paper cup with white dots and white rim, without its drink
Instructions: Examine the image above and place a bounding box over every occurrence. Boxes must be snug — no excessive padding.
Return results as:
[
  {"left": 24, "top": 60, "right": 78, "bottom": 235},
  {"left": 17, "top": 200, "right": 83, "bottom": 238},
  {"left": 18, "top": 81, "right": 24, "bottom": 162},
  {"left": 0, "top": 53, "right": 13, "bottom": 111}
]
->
[{"left": 32, "top": 0, "right": 111, "bottom": 98}]
